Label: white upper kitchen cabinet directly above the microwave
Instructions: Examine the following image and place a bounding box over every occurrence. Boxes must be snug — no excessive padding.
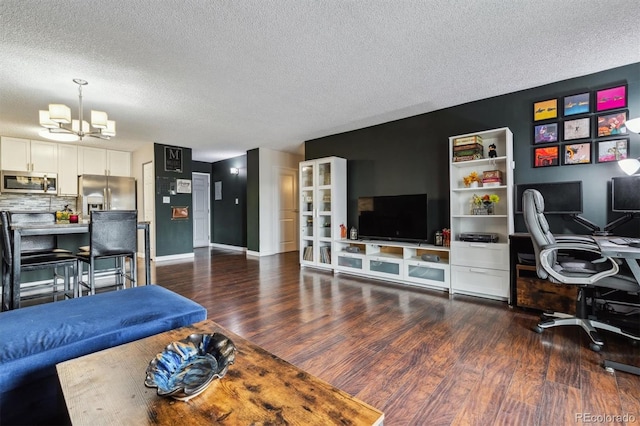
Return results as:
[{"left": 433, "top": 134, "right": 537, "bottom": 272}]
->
[{"left": 0, "top": 136, "right": 58, "bottom": 173}]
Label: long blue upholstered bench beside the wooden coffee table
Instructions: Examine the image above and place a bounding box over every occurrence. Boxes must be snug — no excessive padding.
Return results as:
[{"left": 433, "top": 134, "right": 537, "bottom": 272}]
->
[{"left": 0, "top": 285, "right": 207, "bottom": 425}]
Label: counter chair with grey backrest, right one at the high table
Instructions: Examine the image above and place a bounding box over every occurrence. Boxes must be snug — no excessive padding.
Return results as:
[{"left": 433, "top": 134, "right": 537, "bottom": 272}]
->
[{"left": 75, "top": 210, "right": 138, "bottom": 296}]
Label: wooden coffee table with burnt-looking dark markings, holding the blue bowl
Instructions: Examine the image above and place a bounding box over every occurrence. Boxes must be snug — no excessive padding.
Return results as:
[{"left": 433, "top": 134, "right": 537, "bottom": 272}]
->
[{"left": 57, "top": 320, "right": 384, "bottom": 426}]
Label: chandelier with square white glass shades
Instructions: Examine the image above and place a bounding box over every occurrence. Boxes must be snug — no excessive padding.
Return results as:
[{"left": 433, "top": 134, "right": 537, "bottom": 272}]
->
[{"left": 40, "top": 78, "right": 116, "bottom": 142}]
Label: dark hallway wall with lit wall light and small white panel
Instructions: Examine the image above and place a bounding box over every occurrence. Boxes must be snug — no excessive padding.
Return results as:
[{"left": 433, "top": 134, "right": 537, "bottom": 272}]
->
[{"left": 211, "top": 155, "right": 247, "bottom": 247}]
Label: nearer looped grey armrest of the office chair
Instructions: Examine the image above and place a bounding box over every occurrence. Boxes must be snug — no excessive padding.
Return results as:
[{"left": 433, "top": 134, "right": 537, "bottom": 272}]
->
[{"left": 540, "top": 242, "right": 620, "bottom": 285}]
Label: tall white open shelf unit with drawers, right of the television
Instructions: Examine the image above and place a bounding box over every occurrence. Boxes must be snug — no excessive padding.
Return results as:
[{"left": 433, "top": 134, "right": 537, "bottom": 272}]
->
[{"left": 449, "top": 127, "right": 515, "bottom": 300}]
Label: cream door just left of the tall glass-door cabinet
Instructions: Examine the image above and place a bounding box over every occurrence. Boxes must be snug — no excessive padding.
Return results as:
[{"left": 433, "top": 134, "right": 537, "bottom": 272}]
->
[{"left": 276, "top": 168, "right": 298, "bottom": 253}]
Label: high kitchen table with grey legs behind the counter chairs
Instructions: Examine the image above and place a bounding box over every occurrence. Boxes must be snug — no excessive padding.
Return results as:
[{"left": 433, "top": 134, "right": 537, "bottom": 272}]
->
[{"left": 2, "top": 222, "right": 151, "bottom": 311}]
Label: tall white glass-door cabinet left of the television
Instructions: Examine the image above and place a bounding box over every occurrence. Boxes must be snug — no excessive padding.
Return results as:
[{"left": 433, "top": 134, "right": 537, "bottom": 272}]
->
[{"left": 299, "top": 157, "right": 347, "bottom": 269}]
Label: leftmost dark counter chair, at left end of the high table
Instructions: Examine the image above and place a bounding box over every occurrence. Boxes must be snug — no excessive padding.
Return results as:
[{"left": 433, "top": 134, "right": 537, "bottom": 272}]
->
[{"left": 0, "top": 210, "right": 77, "bottom": 309}]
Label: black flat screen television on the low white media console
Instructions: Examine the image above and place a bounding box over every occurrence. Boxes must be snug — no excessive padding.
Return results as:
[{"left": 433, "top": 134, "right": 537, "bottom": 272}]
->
[{"left": 358, "top": 194, "right": 429, "bottom": 242}]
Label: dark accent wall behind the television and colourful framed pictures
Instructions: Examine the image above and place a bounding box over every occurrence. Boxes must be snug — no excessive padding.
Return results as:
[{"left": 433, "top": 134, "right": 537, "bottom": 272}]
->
[{"left": 305, "top": 64, "right": 640, "bottom": 240}]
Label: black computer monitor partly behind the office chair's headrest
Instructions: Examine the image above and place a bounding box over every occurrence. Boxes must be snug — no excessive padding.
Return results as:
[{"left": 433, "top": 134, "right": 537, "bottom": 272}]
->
[{"left": 515, "top": 181, "right": 582, "bottom": 215}]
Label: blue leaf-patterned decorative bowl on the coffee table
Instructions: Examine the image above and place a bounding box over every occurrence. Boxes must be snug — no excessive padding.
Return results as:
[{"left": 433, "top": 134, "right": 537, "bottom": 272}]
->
[{"left": 144, "top": 333, "right": 236, "bottom": 401}]
